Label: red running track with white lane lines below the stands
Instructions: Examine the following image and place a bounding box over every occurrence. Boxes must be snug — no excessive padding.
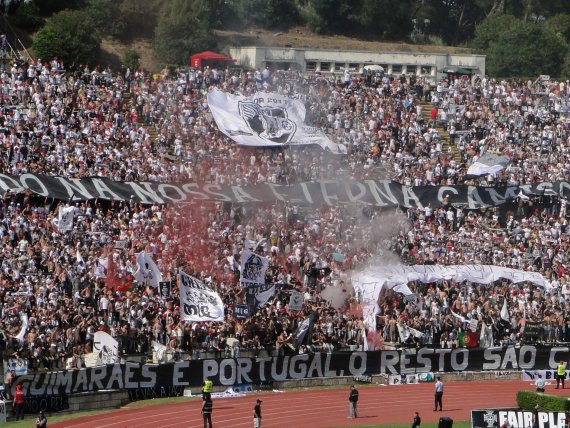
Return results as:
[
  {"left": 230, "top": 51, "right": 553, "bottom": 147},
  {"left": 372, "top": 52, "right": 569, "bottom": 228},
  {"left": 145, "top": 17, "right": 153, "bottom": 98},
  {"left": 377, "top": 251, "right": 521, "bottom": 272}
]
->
[{"left": 49, "top": 380, "right": 570, "bottom": 428}]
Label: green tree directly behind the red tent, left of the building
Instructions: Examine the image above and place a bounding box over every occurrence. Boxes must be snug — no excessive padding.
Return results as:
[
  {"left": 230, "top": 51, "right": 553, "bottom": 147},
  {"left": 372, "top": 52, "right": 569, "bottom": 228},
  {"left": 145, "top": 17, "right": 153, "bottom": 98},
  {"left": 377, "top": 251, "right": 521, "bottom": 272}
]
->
[{"left": 154, "top": 0, "right": 216, "bottom": 64}]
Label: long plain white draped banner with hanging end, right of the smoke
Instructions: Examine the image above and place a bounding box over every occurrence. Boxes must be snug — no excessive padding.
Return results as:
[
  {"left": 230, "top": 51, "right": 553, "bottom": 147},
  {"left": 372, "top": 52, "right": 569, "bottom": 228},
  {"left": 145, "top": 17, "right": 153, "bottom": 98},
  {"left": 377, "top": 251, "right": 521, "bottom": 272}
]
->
[{"left": 352, "top": 260, "right": 550, "bottom": 329}]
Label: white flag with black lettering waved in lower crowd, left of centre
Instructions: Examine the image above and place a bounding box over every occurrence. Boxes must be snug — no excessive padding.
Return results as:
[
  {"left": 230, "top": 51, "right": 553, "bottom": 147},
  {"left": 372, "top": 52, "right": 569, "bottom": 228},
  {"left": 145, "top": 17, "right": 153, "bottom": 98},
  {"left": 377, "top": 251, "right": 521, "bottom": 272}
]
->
[{"left": 178, "top": 272, "right": 224, "bottom": 321}]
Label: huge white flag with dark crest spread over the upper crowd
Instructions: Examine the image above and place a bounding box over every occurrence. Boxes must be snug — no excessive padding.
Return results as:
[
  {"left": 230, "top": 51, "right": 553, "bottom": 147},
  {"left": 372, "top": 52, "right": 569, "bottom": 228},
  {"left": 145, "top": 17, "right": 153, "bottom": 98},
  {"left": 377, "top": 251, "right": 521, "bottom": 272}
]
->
[{"left": 208, "top": 89, "right": 346, "bottom": 154}]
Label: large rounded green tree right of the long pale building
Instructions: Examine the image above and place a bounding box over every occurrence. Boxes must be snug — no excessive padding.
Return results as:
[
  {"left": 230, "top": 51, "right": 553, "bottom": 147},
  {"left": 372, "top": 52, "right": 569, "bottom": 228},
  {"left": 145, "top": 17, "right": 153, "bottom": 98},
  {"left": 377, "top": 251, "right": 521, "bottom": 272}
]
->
[{"left": 486, "top": 21, "right": 568, "bottom": 77}]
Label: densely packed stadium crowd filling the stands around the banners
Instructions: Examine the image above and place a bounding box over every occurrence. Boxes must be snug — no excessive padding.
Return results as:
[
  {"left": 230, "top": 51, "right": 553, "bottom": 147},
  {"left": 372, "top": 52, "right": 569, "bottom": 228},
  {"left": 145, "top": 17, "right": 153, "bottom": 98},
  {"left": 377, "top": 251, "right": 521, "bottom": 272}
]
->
[{"left": 0, "top": 52, "right": 570, "bottom": 378}]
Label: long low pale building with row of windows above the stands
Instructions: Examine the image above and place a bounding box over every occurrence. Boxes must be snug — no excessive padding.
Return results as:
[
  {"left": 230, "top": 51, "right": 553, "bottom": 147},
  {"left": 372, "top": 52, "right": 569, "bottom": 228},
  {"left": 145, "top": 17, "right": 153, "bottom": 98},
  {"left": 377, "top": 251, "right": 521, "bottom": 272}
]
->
[{"left": 230, "top": 46, "right": 485, "bottom": 81}]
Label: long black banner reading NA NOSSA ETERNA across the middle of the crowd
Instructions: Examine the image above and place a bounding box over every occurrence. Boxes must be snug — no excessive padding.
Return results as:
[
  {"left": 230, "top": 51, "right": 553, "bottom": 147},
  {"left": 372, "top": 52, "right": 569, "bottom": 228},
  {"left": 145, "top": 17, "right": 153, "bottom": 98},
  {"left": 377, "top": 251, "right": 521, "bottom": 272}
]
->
[{"left": 0, "top": 174, "right": 570, "bottom": 209}]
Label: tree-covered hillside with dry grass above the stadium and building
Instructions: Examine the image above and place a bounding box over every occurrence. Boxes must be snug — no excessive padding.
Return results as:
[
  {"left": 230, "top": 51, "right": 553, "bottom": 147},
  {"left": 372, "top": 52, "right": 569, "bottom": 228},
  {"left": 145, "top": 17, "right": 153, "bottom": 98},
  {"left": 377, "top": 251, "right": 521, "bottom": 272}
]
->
[{"left": 3, "top": 0, "right": 570, "bottom": 78}]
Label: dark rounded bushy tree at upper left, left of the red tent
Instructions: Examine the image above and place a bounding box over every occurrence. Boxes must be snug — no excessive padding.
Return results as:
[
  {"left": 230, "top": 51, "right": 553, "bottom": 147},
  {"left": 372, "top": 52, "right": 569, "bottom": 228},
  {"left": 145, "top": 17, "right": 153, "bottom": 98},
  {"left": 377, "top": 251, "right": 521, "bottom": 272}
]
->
[{"left": 32, "top": 10, "right": 100, "bottom": 65}]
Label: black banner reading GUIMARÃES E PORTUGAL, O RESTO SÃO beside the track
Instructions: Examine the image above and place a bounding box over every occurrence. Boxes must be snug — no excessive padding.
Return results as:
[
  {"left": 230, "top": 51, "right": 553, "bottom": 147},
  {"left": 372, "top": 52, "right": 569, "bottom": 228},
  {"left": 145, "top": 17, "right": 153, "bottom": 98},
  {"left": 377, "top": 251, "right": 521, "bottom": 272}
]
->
[{"left": 13, "top": 345, "right": 570, "bottom": 397}]
